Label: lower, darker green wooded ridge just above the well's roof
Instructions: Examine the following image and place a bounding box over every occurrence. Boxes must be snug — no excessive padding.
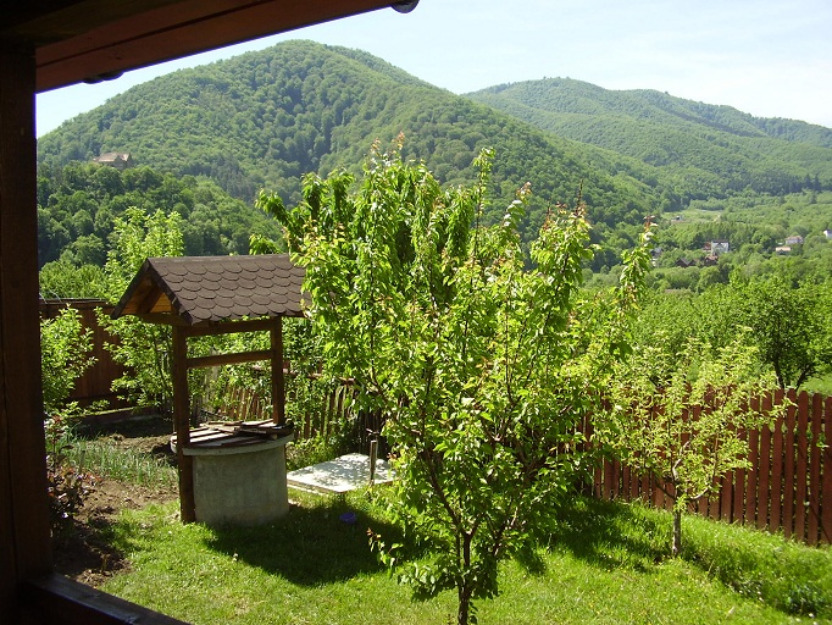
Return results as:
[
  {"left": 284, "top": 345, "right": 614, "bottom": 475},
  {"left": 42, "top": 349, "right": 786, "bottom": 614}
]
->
[{"left": 38, "top": 163, "right": 279, "bottom": 267}]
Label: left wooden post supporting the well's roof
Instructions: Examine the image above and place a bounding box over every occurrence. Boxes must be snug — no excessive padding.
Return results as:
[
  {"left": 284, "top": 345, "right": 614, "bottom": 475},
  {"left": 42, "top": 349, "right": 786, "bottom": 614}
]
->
[{"left": 170, "top": 325, "right": 196, "bottom": 523}]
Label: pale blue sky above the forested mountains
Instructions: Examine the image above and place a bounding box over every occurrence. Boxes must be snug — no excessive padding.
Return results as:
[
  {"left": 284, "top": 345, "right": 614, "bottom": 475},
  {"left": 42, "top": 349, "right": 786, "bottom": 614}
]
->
[{"left": 37, "top": 0, "right": 832, "bottom": 135}]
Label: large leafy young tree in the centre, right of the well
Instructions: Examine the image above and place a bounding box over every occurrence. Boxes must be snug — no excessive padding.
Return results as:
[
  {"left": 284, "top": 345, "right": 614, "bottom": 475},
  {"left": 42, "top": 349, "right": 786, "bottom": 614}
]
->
[{"left": 260, "top": 144, "right": 649, "bottom": 624}]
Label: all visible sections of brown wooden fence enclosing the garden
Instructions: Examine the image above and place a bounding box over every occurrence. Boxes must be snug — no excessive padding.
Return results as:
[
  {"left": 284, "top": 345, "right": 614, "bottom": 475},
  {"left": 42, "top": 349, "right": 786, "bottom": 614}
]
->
[{"left": 41, "top": 300, "right": 832, "bottom": 545}]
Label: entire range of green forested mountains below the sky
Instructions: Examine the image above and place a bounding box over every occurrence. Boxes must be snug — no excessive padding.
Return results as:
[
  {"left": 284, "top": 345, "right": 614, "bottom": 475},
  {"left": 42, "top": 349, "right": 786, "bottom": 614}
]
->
[{"left": 38, "top": 41, "right": 832, "bottom": 270}]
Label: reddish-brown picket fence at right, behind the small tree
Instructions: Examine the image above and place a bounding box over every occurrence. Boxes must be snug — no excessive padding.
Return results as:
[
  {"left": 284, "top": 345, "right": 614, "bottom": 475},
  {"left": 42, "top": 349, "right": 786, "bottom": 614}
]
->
[{"left": 594, "top": 390, "right": 832, "bottom": 545}]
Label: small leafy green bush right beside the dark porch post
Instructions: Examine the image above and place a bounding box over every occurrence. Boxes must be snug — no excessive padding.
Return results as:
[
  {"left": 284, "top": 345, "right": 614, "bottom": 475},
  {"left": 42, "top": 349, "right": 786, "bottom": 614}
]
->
[{"left": 40, "top": 307, "right": 95, "bottom": 416}]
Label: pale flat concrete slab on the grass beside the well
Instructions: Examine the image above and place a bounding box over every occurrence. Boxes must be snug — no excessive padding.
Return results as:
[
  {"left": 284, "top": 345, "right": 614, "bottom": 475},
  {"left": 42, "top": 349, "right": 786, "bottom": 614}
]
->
[{"left": 286, "top": 454, "right": 393, "bottom": 494}]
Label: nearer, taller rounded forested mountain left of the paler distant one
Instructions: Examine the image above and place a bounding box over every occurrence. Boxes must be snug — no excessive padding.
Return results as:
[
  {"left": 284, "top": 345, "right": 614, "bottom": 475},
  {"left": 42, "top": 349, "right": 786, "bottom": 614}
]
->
[{"left": 39, "top": 42, "right": 656, "bottom": 239}]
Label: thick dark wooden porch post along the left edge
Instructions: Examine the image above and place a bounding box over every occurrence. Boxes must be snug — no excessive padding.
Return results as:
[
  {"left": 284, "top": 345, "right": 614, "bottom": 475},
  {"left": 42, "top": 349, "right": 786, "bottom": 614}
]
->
[{"left": 0, "top": 42, "right": 52, "bottom": 615}]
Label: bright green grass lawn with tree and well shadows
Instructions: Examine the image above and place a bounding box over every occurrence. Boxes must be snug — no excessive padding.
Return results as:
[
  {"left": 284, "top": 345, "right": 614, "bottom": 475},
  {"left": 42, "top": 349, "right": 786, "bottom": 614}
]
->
[{"left": 94, "top": 493, "right": 832, "bottom": 625}]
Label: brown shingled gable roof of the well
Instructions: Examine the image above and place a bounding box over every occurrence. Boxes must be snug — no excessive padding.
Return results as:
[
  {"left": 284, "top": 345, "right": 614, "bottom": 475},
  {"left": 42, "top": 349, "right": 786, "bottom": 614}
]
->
[{"left": 112, "top": 254, "right": 305, "bottom": 325}]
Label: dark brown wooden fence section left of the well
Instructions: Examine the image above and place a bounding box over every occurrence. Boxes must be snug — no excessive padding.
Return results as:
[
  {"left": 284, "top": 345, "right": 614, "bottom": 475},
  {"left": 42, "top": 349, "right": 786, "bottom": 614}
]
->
[{"left": 40, "top": 299, "right": 129, "bottom": 408}]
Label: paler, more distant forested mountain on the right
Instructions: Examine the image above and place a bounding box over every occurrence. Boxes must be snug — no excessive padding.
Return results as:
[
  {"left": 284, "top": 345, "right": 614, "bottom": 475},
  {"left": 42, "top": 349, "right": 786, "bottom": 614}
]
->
[{"left": 467, "top": 78, "right": 832, "bottom": 199}]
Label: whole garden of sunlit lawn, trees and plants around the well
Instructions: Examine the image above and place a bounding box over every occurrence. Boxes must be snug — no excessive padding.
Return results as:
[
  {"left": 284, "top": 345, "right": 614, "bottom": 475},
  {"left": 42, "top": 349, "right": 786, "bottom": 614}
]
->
[{"left": 44, "top": 143, "right": 832, "bottom": 625}]
